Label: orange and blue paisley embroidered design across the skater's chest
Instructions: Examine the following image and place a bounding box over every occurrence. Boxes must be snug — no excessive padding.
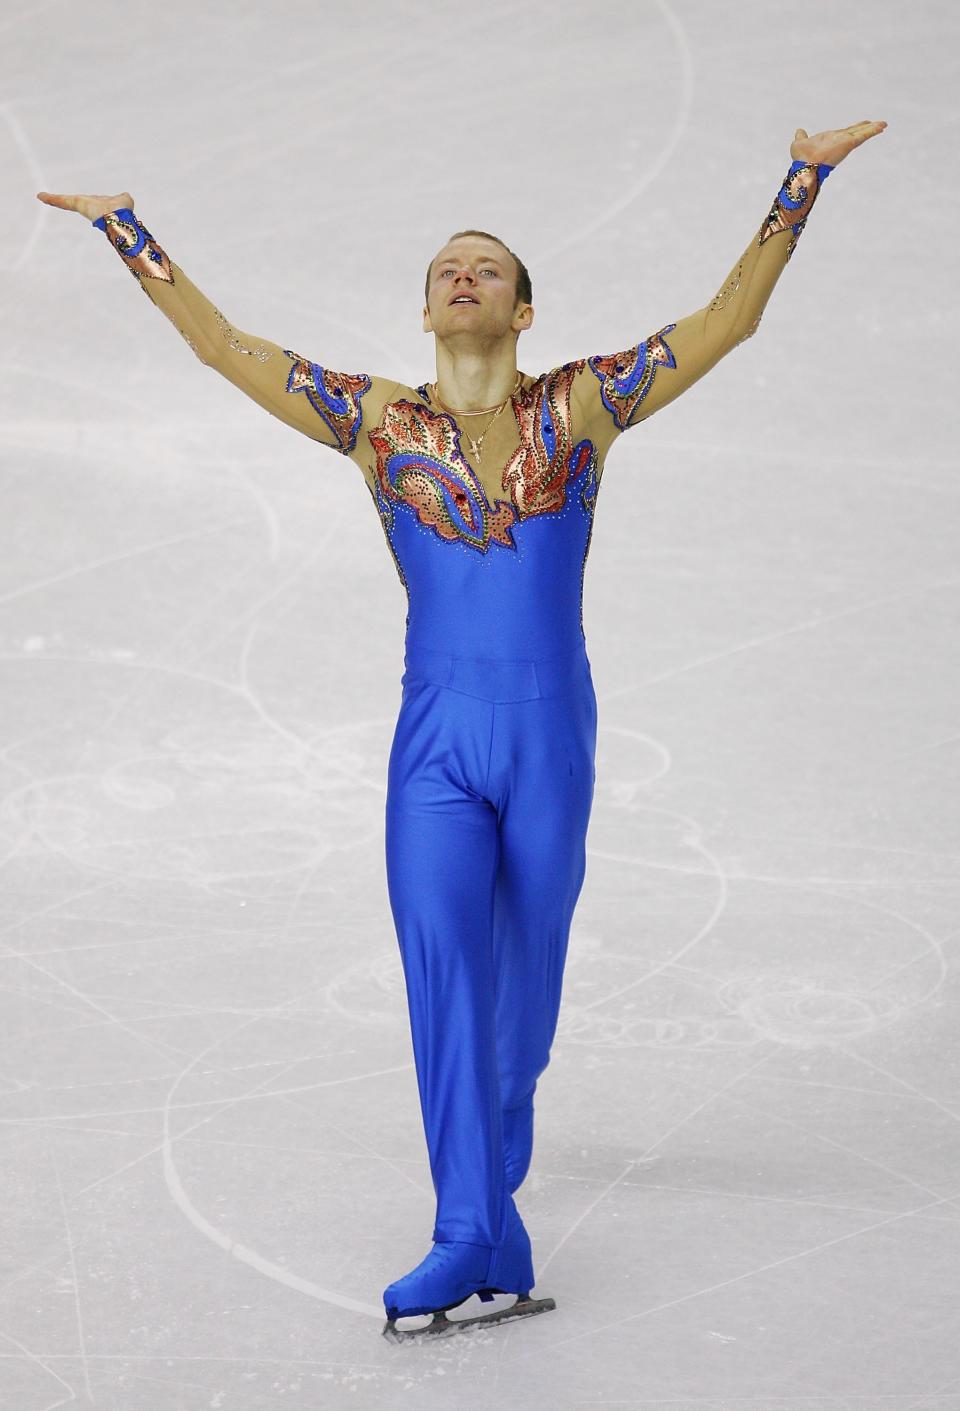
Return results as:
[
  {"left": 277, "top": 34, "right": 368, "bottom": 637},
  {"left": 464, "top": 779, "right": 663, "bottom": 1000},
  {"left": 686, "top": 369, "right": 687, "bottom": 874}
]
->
[{"left": 368, "top": 361, "right": 599, "bottom": 553}]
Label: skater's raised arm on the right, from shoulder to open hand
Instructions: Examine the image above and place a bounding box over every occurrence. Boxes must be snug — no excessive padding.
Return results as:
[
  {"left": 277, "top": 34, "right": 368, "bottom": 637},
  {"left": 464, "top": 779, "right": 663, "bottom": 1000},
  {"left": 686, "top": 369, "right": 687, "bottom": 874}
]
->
[{"left": 575, "top": 123, "right": 887, "bottom": 446}]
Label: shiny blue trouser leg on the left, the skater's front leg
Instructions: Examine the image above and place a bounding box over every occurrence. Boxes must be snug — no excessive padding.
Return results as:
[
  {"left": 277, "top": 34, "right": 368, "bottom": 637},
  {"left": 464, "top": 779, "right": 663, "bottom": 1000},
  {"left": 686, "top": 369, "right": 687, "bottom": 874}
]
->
[{"left": 385, "top": 682, "right": 505, "bottom": 1245}]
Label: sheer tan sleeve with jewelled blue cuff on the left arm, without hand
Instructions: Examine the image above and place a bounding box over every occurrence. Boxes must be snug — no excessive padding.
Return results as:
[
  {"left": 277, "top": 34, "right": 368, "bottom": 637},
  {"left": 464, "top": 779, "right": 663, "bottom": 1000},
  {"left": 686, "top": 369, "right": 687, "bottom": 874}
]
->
[{"left": 93, "top": 209, "right": 398, "bottom": 456}]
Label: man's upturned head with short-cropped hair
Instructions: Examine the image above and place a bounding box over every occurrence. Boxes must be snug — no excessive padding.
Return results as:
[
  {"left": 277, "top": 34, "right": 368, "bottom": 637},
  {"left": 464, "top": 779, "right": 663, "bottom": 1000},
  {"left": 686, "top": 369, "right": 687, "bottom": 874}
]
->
[{"left": 424, "top": 236, "right": 534, "bottom": 343}]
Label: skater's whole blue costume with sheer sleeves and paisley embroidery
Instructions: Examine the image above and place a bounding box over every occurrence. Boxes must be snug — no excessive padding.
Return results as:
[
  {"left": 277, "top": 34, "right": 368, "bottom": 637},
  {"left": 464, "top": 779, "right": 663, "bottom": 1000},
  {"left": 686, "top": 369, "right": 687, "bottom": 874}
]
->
[{"left": 95, "top": 162, "right": 832, "bottom": 1322}]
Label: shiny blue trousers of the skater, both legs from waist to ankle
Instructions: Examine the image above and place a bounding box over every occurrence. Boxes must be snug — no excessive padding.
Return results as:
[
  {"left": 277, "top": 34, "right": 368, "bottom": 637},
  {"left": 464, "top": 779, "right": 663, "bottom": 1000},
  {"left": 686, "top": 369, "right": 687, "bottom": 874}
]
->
[{"left": 387, "top": 646, "right": 596, "bottom": 1245}]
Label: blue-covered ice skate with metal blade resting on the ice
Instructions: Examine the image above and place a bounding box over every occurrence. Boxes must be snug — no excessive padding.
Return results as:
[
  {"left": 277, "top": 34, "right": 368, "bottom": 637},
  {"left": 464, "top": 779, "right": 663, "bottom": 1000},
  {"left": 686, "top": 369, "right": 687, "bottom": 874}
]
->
[{"left": 383, "top": 1218, "right": 556, "bottom": 1342}]
